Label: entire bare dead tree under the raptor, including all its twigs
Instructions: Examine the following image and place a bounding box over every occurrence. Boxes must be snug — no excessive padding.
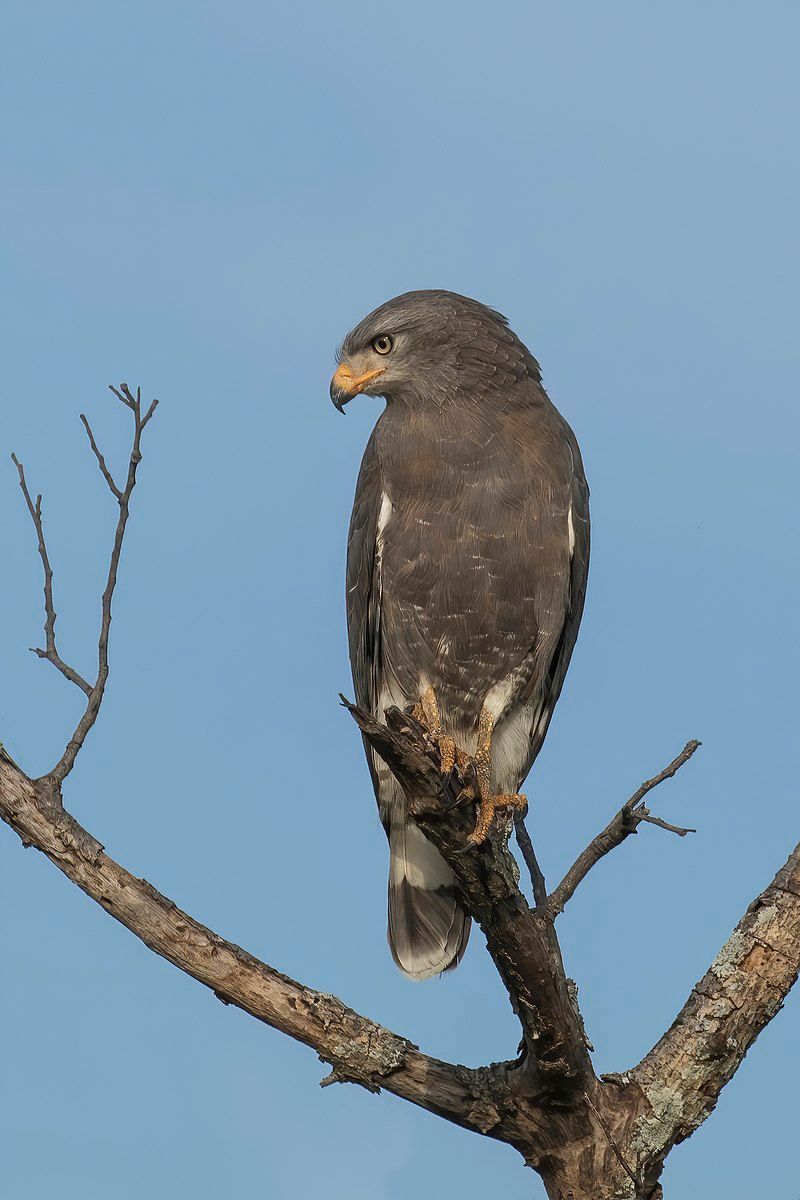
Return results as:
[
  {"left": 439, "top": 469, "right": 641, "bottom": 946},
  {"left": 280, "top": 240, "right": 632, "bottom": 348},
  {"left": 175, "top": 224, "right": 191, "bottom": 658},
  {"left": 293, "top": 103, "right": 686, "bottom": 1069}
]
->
[{"left": 0, "top": 384, "right": 800, "bottom": 1200}]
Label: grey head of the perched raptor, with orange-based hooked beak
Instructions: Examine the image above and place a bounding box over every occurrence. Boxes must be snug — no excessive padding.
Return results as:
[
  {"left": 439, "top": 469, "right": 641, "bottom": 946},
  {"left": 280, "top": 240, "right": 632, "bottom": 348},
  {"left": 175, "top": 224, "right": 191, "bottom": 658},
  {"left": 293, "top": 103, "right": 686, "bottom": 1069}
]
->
[{"left": 331, "top": 292, "right": 539, "bottom": 413}]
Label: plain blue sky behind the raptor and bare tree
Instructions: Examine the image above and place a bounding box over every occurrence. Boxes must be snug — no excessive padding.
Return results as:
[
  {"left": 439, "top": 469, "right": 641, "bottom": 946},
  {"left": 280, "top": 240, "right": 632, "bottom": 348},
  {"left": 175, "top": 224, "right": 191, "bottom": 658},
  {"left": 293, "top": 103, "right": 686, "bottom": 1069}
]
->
[{"left": 0, "top": 0, "right": 800, "bottom": 1200}]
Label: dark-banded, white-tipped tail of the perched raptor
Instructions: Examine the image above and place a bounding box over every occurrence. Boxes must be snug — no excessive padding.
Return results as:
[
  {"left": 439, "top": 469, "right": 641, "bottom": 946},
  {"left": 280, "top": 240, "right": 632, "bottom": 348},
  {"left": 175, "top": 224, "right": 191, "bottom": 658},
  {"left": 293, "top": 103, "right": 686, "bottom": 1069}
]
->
[{"left": 389, "top": 814, "right": 470, "bottom": 979}]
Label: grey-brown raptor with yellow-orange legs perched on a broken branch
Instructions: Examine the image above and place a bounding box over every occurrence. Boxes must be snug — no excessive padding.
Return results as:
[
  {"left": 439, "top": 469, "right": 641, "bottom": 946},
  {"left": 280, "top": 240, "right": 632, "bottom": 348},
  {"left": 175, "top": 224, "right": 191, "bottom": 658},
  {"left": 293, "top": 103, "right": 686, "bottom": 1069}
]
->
[{"left": 331, "top": 290, "right": 589, "bottom": 979}]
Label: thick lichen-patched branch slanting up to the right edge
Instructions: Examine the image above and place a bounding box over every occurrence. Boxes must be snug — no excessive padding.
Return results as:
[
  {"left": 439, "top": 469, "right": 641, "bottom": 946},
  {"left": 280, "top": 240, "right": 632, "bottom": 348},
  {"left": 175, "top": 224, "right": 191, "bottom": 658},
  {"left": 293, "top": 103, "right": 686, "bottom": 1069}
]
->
[{"left": 625, "top": 845, "right": 800, "bottom": 1160}]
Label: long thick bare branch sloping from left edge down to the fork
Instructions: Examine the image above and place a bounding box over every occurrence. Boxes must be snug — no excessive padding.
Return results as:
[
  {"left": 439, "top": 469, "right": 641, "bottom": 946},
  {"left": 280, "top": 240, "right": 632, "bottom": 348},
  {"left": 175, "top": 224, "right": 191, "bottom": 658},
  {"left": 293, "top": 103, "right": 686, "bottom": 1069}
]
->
[{"left": 0, "top": 746, "right": 525, "bottom": 1145}]
